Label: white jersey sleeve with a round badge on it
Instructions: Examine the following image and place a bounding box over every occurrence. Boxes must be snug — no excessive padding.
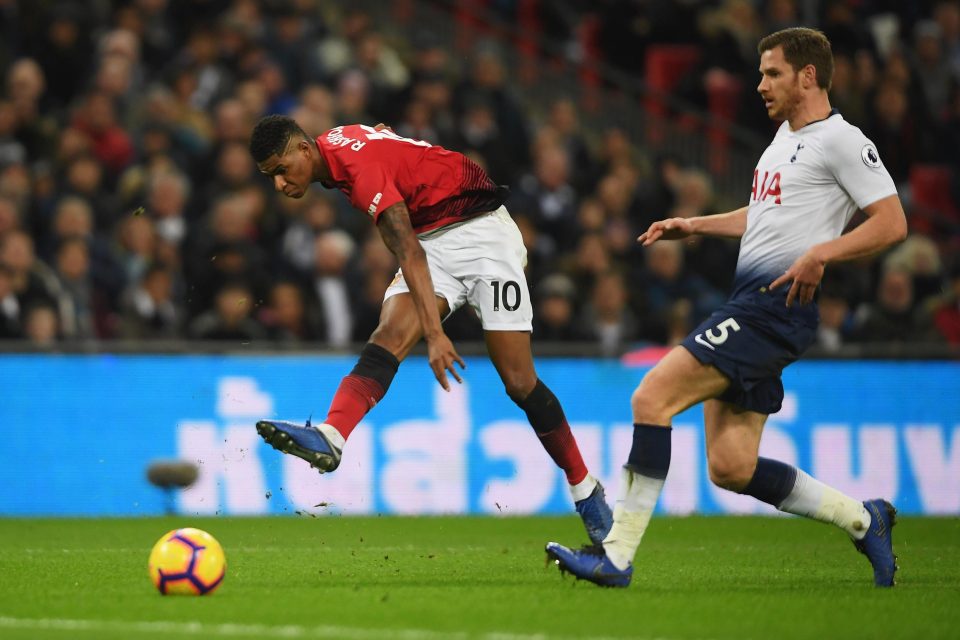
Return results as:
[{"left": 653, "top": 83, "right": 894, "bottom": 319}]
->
[{"left": 824, "top": 127, "right": 897, "bottom": 209}]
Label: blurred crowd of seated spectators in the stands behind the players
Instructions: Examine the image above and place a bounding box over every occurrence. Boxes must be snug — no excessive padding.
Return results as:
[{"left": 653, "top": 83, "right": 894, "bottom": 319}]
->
[{"left": 0, "top": 0, "right": 960, "bottom": 354}]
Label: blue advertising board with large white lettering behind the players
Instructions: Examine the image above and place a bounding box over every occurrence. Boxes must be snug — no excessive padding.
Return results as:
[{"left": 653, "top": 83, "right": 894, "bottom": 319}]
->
[{"left": 0, "top": 355, "right": 960, "bottom": 516}]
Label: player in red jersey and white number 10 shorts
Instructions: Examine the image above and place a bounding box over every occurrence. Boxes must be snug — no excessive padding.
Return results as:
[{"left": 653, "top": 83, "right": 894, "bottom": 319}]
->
[{"left": 250, "top": 115, "right": 612, "bottom": 543}]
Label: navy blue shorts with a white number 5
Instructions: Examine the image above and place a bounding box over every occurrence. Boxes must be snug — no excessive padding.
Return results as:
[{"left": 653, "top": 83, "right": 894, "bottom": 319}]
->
[{"left": 681, "top": 291, "right": 818, "bottom": 415}]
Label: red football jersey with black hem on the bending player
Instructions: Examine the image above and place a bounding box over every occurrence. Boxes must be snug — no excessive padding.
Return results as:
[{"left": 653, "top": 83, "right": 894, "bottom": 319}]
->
[{"left": 317, "top": 124, "right": 507, "bottom": 233}]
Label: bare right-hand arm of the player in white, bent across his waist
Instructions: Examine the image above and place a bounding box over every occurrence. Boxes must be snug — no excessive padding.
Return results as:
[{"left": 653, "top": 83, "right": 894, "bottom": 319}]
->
[{"left": 770, "top": 195, "right": 907, "bottom": 307}]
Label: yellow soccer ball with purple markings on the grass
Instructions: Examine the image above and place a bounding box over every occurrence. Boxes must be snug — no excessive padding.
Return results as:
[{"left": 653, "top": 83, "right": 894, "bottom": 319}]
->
[{"left": 148, "top": 527, "right": 227, "bottom": 596}]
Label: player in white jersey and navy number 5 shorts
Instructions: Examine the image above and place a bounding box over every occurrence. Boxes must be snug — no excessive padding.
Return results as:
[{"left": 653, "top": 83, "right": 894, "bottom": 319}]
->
[{"left": 547, "top": 28, "right": 907, "bottom": 587}]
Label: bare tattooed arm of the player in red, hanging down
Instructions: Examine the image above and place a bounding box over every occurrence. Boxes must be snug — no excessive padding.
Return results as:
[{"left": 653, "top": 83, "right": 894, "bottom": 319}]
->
[{"left": 377, "top": 202, "right": 466, "bottom": 391}]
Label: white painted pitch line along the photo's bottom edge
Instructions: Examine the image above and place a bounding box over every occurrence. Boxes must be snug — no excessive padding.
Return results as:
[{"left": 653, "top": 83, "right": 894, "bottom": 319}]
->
[{"left": 0, "top": 616, "right": 667, "bottom": 640}]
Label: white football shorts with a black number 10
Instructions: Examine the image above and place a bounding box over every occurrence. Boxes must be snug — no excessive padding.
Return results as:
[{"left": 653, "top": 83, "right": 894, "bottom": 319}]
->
[{"left": 383, "top": 206, "right": 533, "bottom": 331}]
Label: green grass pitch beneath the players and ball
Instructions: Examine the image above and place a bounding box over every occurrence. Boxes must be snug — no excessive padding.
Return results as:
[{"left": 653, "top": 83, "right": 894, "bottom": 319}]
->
[{"left": 0, "top": 516, "right": 960, "bottom": 640}]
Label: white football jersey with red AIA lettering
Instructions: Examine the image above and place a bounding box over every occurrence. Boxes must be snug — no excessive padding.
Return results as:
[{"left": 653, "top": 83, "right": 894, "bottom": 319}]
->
[{"left": 733, "top": 110, "right": 897, "bottom": 297}]
